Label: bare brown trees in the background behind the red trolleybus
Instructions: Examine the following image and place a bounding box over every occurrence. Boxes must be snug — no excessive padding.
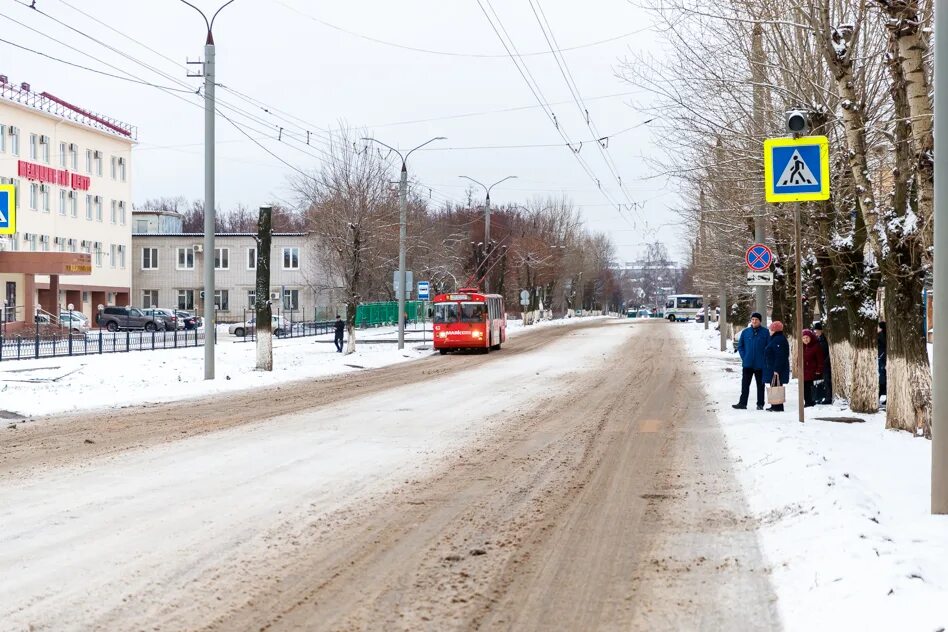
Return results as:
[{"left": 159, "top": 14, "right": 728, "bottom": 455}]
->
[{"left": 139, "top": 132, "right": 628, "bottom": 339}]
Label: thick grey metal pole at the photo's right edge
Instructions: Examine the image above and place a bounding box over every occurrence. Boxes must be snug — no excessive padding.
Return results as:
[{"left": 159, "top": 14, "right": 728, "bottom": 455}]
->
[{"left": 926, "top": 4, "right": 948, "bottom": 514}]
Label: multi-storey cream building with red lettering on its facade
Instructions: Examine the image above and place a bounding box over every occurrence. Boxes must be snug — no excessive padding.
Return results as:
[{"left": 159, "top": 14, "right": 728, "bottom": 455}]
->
[{"left": 0, "top": 75, "right": 137, "bottom": 323}]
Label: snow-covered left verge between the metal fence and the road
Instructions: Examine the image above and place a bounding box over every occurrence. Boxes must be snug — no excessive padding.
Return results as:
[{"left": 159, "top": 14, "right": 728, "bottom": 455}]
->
[{"left": 0, "top": 318, "right": 604, "bottom": 417}]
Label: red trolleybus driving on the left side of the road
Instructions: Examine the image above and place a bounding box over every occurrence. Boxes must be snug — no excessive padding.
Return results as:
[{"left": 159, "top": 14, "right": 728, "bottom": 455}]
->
[{"left": 433, "top": 288, "right": 507, "bottom": 354}]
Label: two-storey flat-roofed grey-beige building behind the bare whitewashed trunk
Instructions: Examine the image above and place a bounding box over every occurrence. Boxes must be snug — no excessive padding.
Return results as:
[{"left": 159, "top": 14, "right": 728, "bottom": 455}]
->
[{"left": 131, "top": 231, "right": 335, "bottom": 322}]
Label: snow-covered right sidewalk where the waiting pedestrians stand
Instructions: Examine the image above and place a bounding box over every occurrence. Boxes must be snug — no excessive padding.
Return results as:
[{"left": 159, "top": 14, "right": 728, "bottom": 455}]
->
[{"left": 679, "top": 323, "right": 948, "bottom": 631}]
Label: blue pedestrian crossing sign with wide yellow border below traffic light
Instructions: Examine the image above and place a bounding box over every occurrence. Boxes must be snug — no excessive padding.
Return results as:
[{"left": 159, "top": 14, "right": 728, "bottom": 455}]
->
[{"left": 764, "top": 136, "right": 830, "bottom": 203}]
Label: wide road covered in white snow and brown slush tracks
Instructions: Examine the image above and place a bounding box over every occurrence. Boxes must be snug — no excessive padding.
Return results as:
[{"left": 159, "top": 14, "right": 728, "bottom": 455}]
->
[{"left": 0, "top": 320, "right": 779, "bottom": 630}]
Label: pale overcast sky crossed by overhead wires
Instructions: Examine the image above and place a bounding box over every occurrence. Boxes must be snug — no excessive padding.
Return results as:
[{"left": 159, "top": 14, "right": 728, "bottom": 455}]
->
[{"left": 0, "top": 0, "right": 682, "bottom": 260}]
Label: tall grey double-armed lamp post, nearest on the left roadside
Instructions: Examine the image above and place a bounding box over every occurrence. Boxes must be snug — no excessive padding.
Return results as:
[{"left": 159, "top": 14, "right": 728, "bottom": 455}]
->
[{"left": 181, "top": 0, "right": 234, "bottom": 380}]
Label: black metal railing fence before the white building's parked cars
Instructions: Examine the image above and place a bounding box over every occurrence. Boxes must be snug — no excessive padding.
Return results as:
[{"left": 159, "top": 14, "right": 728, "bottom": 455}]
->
[{"left": 0, "top": 329, "right": 205, "bottom": 361}]
